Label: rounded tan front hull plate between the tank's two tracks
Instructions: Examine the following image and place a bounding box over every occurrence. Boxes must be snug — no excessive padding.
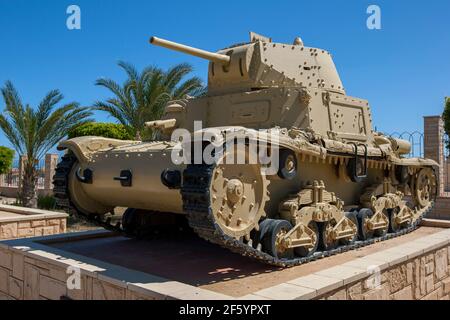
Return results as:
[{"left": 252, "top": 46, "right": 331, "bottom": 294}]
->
[{"left": 58, "top": 138, "right": 185, "bottom": 214}]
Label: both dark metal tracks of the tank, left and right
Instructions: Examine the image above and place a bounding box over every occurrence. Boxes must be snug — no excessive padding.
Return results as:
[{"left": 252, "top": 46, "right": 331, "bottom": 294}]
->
[{"left": 53, "top": 154, "right": 433, "bottom": 267}]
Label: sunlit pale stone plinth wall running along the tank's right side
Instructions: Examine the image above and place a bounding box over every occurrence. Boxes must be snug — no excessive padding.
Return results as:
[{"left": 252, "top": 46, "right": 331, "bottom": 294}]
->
[{"left": 247, "top": 228, "right": 450, "bottom": 300}]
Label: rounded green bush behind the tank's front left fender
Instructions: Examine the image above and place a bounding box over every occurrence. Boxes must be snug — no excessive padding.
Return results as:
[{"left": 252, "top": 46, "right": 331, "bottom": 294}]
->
[{"left": 68, "top": 122, "right": 133, "bottom": 140}]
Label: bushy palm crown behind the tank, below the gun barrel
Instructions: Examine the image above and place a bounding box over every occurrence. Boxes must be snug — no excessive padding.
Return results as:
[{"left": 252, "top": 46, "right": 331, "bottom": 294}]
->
[{"left": 94, "top": 61, "right": 205, "bottom": 140}]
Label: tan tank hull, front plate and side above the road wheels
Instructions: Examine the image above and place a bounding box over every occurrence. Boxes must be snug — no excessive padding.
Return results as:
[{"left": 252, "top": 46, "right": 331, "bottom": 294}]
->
[{"left": 59, "top": 131, "right": 435, "bottom": 217}]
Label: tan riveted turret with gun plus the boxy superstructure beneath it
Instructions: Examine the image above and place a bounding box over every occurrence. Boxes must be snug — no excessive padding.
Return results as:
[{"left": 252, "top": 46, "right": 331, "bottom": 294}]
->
[{"left": 150, "top": 32, "right": 373, "bottom": 143}]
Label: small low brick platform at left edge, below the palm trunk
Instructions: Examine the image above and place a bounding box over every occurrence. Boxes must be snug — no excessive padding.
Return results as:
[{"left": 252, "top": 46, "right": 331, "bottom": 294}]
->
[{"left": 0, "top": 205, "right": 67, "bottom": 240}]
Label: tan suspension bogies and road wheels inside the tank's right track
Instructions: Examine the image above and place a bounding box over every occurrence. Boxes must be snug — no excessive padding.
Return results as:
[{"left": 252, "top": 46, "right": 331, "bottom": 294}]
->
[{"left": 262, "top": 167, "right": 435, "bottom": 258}]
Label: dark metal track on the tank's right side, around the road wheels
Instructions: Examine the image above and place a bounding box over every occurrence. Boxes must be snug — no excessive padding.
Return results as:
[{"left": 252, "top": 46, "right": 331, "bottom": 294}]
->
[{"left": 181, "top": 165, "right": 433, "bottom": 267}]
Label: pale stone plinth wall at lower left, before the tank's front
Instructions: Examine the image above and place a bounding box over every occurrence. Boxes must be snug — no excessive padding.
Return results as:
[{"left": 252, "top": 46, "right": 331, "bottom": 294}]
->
[{"left": 0, "top": 231, "right": 230, "bottom": 300}]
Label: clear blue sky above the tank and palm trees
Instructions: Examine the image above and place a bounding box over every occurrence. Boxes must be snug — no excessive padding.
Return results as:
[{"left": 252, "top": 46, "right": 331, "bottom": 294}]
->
[{"left": 0, "top": 0, "right": 450, "bottom": 151}]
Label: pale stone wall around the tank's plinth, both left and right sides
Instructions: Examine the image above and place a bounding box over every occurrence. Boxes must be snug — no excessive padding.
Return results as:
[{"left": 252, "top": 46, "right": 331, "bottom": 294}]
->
[{"left": 0, "top": 226, "right": 450, "bottom": 300}]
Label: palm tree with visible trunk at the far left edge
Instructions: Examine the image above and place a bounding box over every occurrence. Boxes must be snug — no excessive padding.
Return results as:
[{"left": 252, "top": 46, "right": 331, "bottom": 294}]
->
[{"left": 0, "top": 81, "right": 91, "bottom": 207}]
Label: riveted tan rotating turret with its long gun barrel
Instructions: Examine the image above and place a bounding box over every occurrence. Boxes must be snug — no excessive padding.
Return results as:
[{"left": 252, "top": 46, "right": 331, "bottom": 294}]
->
[{"left": 150, "top": 32, "right": 345, "bottom": 95}]
